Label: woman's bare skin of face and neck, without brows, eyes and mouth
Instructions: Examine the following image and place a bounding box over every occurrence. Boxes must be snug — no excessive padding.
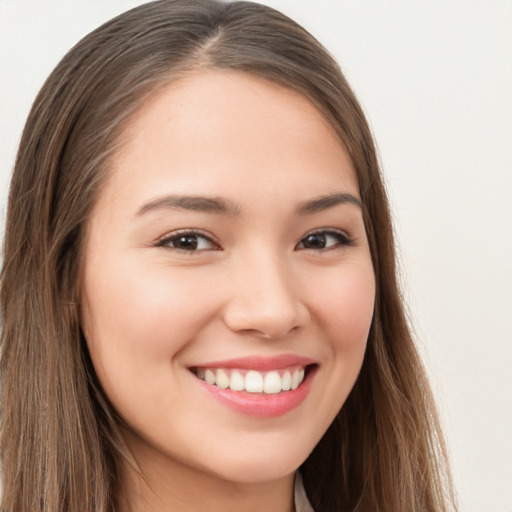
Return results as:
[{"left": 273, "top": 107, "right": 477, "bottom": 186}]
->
[{"left": 83, "top": 71, "right": 375, "bottom": 512}]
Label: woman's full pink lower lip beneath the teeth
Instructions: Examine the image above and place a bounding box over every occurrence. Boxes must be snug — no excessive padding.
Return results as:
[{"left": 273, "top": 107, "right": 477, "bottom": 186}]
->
[{"left": 197, "top": 367, "right": 316, "bottom": 418}]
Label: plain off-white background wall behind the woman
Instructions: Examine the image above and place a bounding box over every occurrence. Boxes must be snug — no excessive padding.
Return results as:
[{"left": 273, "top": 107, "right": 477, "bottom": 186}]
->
[{"left": 0, "top": 0, "right": 512, "bottom": 512}]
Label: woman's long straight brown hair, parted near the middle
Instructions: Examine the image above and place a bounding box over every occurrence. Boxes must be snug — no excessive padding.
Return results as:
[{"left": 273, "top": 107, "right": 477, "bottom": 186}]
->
[{"left": 0, "top": 0, "right": 455, "bottom": 512}]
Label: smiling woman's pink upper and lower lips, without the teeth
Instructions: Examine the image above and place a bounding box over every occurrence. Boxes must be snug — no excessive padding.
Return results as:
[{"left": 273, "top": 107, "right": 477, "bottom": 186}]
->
[{"left": 191, "top": 356, "right": 318, "bottom": 418}]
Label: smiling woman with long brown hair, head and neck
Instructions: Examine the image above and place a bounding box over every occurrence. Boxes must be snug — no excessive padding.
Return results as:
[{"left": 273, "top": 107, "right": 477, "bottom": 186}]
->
[{"left": 0, "top": 0, "right": 453, "bottom": 512}]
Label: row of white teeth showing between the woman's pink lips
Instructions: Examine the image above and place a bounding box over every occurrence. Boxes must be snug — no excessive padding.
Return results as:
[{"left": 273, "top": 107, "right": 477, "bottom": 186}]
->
[{"left": 190, "top": 365, "right": 311, "bottom": 395}]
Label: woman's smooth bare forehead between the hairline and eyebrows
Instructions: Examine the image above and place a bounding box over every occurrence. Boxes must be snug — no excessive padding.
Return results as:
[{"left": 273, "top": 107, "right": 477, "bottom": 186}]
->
[{"left": 99, "top": 71, "right": 357, "bottom": 210}]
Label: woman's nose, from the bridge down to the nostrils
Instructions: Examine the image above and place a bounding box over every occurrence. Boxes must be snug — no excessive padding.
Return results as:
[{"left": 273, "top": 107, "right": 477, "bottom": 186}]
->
[{"left": 224, "top": 253, "right": 310, "bottom": 339}]
